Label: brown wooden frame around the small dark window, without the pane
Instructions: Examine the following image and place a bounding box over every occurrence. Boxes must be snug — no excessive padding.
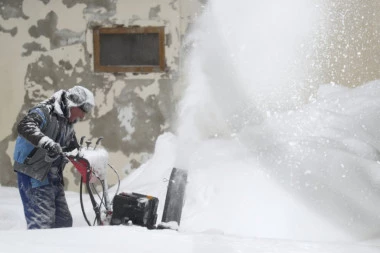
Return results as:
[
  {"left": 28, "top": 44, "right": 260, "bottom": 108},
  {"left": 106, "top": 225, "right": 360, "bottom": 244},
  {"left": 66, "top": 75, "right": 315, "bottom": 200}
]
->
[{"left": 93, "top": 26, "right": 165, "bottom": 73}]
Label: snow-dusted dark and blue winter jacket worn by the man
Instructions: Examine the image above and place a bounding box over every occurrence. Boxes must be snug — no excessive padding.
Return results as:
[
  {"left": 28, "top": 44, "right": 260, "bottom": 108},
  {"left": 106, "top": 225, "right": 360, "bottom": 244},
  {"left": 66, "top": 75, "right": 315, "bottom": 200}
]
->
[{"left": 13, "top": 91, "right": 79, "bottom": 181}]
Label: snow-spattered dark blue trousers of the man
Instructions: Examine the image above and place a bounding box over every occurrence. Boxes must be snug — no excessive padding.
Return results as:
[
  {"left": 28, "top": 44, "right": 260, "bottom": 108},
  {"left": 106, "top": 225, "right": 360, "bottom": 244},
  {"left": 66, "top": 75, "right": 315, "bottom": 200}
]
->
[{"left": 17, "top": 172, "right": 73, "bottom": 229}]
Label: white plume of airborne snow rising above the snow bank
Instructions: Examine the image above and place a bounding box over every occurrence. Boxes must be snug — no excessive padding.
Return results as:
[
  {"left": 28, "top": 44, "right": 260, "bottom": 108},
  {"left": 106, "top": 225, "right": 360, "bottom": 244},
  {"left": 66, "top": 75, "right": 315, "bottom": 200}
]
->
[{"left": 178, "top": 0, "right": 319, "bottom": 142}]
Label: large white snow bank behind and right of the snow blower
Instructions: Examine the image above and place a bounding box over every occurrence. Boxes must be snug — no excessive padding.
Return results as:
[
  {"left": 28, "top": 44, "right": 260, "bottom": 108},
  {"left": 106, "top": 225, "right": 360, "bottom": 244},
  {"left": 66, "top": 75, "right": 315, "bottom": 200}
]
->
[{"left": 110, "top": 78, "right": 380, "bottom": 241}]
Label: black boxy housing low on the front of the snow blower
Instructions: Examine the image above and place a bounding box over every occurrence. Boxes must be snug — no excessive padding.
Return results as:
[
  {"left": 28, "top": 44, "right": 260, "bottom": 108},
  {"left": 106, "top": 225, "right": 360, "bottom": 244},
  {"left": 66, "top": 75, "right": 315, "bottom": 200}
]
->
[{"left": 111, "top": 192, "right": 158, "bottom": 229}]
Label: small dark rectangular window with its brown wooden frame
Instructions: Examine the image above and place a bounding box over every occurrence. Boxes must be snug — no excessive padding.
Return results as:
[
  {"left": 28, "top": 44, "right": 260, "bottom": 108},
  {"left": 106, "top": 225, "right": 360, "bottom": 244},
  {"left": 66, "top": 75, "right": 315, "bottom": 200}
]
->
[{"left": 94, "top": 27, "right": 165, "bottom": 73}]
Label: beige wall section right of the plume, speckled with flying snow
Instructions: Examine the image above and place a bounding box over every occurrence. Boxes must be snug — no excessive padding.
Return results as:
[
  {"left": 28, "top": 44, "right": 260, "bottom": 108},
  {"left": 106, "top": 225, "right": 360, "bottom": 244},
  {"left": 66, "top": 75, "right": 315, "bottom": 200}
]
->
[{"left": 309, "top": 0, "right": 380, "bottom": 87}]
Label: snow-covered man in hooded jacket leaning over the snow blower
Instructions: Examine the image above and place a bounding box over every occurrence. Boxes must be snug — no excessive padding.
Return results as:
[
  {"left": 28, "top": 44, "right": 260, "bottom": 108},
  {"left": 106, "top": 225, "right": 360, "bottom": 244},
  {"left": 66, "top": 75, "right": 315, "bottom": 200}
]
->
[{"left": 14, "top": 86, "right": 95, "bottom": 229}]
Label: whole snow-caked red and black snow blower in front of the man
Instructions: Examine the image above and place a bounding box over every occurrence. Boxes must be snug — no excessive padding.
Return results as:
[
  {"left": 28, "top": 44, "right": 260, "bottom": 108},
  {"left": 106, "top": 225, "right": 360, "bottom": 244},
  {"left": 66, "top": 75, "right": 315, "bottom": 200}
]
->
[{"left": 65, "top": 136, "right": 187, "bottom": 229}]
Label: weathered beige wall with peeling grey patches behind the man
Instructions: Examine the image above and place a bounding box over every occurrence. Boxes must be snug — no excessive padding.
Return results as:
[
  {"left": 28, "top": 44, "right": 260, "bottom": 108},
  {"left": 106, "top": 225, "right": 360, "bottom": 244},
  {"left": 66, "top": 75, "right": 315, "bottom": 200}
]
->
[{"left": 0, "top": 0, "right": 204, "bottom": 190}]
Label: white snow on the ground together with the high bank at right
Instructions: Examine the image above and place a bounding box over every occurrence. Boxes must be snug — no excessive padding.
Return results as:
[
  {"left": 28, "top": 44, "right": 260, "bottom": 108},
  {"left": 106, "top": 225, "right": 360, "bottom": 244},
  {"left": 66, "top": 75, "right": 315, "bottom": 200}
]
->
[{"left": 0, "top": 81, "right": 380, "bottom": 252}]
